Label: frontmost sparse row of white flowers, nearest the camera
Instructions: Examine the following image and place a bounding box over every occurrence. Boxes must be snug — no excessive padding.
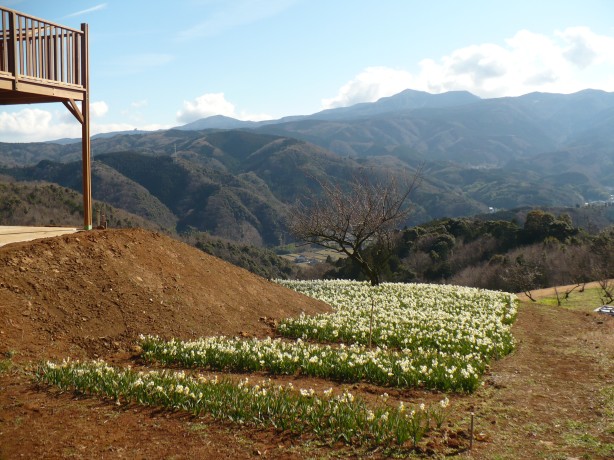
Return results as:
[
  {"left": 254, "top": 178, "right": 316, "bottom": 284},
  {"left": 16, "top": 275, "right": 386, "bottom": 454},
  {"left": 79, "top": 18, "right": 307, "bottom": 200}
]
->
[{"left": 36, "top": 361, "right": 449, "bottom": 446}]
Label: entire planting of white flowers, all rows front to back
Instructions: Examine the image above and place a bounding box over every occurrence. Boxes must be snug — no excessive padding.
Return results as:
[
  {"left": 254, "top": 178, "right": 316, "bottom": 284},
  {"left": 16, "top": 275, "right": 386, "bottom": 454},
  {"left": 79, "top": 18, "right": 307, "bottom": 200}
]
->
[{"left": 37, "top": 281, "right": 517, "bottom": 447}]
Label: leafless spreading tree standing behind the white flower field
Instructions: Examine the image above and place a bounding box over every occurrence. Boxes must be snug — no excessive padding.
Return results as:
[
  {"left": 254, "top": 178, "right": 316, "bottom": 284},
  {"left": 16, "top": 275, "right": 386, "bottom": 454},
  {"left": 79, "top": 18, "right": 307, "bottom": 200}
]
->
[{"left": 289, "top": 168, "right": 421, "bottom": 286}]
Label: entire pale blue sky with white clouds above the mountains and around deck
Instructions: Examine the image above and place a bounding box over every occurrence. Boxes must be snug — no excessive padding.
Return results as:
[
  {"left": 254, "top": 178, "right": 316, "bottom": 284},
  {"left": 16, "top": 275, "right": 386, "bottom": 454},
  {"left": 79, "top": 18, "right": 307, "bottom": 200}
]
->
[{"left": 0, "top": 0, "right": 614, "bottom": 142}]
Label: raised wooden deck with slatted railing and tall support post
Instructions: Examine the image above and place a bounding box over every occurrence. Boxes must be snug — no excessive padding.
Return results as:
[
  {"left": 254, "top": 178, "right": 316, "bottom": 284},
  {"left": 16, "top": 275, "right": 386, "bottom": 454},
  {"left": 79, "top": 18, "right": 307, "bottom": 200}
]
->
[{"left": 0, "top": 7, "right": 92, "bottom": 229}]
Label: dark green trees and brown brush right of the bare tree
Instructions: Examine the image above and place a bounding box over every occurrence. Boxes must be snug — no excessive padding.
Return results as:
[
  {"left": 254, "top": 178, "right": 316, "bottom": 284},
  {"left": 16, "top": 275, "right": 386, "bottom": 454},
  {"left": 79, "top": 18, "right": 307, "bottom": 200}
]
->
[{"left": 324, "top": 206, "right": 614, "bottom": 292}]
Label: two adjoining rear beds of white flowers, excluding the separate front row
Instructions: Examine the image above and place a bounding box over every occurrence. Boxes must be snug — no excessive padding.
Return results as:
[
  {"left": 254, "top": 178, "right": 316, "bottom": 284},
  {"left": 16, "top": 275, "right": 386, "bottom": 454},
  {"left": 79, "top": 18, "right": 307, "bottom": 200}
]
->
[{"left": 141, "top": 281, "right": 516, "bottom": 392}]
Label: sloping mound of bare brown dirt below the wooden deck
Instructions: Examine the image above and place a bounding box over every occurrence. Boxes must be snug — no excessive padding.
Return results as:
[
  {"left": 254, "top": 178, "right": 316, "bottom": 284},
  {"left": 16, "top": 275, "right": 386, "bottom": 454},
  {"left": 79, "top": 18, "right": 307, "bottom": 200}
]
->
[{"left": 0, "top": 229, "right": 329, "bottom": 358}]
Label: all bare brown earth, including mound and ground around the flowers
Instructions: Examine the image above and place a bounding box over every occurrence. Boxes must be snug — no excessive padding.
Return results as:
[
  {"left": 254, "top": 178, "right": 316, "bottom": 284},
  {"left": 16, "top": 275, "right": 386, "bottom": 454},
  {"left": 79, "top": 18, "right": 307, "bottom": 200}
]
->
[{"left": 0, "top": 230, "right": 614, "bottom": 459}]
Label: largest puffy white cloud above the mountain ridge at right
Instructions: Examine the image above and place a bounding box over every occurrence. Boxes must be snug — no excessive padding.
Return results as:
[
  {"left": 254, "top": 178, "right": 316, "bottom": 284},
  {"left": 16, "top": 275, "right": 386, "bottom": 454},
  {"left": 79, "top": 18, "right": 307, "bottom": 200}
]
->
[{"left": 322, "top": 27, "right": 614, "bottom": 108}]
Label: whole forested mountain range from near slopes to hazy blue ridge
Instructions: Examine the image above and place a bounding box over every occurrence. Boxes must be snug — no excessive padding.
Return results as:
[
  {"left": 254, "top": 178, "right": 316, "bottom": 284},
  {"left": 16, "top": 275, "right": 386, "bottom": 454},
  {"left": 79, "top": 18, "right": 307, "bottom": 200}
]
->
[{"left": 0, "top": 86, "right": 614, "bottom": 245}]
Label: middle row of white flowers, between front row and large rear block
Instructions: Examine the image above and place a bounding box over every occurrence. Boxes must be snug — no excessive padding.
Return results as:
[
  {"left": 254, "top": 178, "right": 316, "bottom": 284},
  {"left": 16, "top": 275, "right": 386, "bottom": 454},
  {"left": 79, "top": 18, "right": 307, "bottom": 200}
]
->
[{"left": 141, "top": 336, "right": 484, "bottom": 392}]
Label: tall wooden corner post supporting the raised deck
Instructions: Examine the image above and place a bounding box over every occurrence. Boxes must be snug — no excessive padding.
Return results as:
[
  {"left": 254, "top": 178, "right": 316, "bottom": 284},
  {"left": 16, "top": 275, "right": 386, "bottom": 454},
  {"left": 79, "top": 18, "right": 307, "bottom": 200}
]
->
[{"left": 81, "top": 24, "right": 92, "bottom": 230}]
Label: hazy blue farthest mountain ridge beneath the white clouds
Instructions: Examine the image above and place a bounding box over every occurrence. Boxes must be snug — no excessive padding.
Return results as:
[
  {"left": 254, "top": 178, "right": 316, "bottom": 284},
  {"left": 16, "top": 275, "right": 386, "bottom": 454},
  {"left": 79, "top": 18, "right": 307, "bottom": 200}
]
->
[{"left": 45, "top": 89, "right": 614, "bottom": 171}]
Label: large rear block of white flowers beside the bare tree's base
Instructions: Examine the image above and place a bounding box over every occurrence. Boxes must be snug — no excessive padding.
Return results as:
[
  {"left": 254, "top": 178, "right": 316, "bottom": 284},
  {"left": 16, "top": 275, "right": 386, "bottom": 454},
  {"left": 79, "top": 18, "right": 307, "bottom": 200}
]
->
[{"left": 278, "top": 280, "right": 517, "bottom": 360}]
